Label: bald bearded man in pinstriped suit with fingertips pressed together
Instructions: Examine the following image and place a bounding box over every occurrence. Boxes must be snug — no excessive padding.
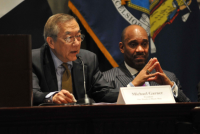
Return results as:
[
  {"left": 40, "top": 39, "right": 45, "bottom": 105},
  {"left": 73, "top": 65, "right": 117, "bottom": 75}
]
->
[{"left": 104, "top": 25, "right": 190, "bottom": 102}]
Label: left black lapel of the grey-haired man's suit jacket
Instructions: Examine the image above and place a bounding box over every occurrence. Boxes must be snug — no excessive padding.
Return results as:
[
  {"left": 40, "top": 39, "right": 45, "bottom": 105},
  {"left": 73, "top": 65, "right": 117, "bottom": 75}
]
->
[{"left": 43, "top": 46, "right": 58, "bottom": 91}]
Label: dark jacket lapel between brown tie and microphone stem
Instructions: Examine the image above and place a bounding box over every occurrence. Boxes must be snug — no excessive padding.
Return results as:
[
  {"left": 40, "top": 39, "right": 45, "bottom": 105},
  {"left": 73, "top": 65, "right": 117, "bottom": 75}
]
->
[{"left": 72, "top": 59, "right": 87, "bottom": 99}]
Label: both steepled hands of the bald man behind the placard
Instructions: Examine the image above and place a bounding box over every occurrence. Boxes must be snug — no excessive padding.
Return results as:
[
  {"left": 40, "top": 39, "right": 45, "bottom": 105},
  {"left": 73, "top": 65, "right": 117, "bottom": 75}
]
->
[{"left": 132, "top": 58, "right": 174, "bottom": 87}]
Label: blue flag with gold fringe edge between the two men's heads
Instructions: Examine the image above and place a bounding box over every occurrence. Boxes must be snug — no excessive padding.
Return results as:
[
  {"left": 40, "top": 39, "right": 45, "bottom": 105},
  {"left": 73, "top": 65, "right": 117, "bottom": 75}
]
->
[{"left": 69, "top": 0, "right": 150, "bottom": 67}]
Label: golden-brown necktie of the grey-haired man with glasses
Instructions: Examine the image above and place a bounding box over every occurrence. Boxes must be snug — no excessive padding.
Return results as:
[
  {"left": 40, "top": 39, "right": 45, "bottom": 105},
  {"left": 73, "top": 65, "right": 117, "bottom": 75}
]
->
[{"left": 62, "top": 63, "right": 73, "bottom": 93}]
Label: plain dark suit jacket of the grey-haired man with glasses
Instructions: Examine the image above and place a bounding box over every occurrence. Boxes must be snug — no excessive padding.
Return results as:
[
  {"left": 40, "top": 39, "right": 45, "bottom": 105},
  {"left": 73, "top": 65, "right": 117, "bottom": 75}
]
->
[{"left": 32, "top": 44, "right": 118, "bottom": 105}]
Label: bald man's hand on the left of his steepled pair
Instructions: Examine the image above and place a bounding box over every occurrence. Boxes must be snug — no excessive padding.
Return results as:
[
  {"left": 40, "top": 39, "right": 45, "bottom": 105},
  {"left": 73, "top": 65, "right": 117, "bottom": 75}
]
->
[{"left": 132, "top": 58, "right": 158, "bottom": 86}]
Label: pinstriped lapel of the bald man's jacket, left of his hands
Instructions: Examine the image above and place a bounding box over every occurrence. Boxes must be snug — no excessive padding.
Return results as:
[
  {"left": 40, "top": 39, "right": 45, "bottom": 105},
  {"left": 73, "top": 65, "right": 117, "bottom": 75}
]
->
[{"left": 116, "top": 64, "right": 133, "bottom": 87}]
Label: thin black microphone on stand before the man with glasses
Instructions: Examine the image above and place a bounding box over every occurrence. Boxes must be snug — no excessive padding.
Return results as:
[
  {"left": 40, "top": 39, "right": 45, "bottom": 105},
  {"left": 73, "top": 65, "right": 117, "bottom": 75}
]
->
[{"left": 76, "top": 56, "right": 95, "bottom": 105}]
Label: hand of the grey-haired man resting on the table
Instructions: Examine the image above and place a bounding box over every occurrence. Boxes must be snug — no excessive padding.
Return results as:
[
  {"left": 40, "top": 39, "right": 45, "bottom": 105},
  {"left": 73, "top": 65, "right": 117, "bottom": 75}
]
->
[{"left": 52, "top": 89, "right": 74, "bottom": 104}]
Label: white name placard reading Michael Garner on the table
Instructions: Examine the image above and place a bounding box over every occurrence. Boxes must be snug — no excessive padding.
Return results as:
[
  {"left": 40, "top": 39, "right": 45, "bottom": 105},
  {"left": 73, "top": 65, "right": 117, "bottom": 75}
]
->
[{"left": 117, "top": 85, "right": 176, "bottom": 104}]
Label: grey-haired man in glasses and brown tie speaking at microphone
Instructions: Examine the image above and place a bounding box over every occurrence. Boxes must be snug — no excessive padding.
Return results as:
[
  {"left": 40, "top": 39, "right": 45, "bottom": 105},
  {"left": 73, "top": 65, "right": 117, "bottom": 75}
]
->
[{"left": 32, "top": 14, "right": 118, "bottom": 105}]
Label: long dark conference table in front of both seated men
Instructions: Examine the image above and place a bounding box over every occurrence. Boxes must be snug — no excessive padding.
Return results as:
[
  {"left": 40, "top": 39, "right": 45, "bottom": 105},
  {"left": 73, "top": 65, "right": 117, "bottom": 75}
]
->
[{"left": 0, "top": 102, "right": 200, "bottom": 134}]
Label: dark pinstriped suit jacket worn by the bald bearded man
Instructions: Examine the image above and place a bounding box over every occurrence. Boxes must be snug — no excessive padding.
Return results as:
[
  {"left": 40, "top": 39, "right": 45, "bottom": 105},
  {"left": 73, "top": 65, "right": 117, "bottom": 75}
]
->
[{"left": 103, "top": 64, "right": 190, "bottom": 102}]
